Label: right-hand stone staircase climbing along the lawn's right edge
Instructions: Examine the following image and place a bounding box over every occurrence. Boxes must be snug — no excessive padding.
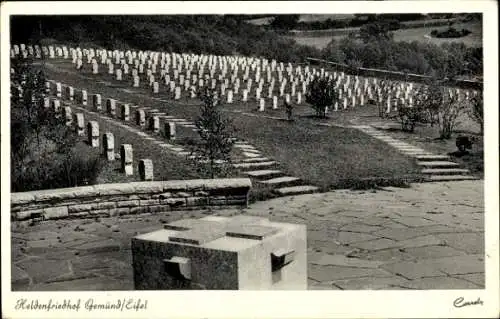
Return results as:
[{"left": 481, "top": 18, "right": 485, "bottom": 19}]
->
[{"left": 352, "top": 125, "right": 477, "bottom": 182}]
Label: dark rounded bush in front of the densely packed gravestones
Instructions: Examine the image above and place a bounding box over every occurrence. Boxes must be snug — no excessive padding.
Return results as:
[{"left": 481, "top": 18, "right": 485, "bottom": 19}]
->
[{"left": 306, "top": 77, "right": 338, "bottom": 118}]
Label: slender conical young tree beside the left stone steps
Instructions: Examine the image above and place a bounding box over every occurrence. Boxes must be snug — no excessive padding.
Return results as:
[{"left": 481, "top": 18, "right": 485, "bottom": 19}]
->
[{"left": 193, "top": 87, "right": 234, "bottom": 178}]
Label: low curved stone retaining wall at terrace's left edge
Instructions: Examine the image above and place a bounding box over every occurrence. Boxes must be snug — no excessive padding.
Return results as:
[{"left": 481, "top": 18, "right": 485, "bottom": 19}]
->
[{"left": 11, "top": 178, "right": 252, "bottom": 222}]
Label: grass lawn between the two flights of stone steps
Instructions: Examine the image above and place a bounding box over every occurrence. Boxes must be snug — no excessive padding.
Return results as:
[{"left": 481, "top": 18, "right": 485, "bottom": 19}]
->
[{"left": 227, "top": 113, "right": 418, "bottom": 189}]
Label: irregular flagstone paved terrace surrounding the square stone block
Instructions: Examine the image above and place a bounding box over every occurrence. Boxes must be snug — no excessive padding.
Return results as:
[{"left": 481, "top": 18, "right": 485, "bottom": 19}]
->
[{"left": 12, "top": 180, "right": 484, "bottom": 291}]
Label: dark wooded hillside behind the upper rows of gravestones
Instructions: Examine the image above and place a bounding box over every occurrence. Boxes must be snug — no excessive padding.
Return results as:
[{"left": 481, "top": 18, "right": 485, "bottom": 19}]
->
[{"left": 11, "top": 15, "right": 319, "bottom": 62}]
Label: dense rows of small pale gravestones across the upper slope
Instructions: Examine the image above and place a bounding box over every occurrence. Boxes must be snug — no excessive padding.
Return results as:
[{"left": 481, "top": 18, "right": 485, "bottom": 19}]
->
[{"left": 11, "top": 45, "right": 477, "bottom": 113}]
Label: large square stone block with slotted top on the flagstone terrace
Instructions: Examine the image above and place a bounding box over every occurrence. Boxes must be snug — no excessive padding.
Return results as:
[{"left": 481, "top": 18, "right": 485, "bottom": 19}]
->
[{"left": 131, "top": 216, "right": 307, "bottom": 290}]
